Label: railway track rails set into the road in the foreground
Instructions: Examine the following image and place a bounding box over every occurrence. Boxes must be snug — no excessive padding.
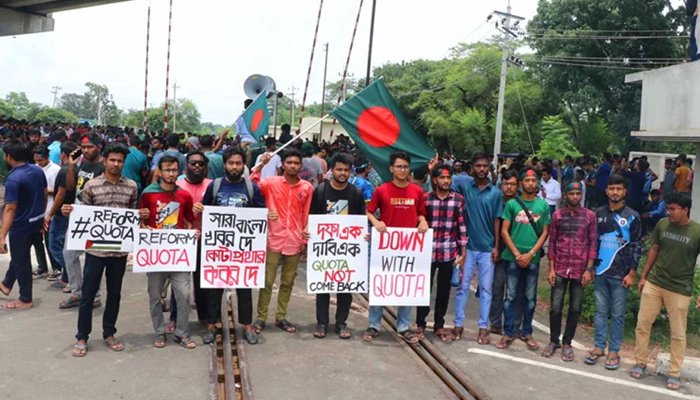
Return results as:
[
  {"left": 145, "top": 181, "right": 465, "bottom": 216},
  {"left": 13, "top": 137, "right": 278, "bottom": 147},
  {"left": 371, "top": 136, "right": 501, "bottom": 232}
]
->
[{"left": 212, "top": 291, "right": 491, "bottom": 400}]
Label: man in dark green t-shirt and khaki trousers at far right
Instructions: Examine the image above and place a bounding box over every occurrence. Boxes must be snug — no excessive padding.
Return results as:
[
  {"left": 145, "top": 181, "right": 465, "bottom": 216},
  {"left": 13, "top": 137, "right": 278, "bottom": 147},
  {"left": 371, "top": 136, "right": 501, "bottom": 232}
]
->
[{"left": 630, "top": 192, "right": 700, "bottom": 390}]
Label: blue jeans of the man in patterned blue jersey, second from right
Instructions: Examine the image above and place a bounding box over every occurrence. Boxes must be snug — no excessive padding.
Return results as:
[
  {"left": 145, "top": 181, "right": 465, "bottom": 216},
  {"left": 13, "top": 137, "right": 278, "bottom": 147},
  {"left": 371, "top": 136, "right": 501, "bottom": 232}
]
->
[{"left": 595, "top": 275, "right": 628, "bottom": 353}]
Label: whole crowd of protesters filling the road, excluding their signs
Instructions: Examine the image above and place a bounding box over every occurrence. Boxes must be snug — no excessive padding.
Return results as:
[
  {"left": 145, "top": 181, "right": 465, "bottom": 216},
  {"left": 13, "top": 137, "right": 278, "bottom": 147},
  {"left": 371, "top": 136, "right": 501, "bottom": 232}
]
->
[{"left": 0, "top": 119, "right": 700, "bottom": 390}]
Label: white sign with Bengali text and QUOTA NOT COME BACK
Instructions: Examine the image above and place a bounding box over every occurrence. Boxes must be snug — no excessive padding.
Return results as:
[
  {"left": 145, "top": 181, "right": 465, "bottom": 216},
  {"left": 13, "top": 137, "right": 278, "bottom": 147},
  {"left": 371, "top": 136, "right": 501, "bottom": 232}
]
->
[{"left": 306, "top": 215, "right": 368, "bottom": 293}]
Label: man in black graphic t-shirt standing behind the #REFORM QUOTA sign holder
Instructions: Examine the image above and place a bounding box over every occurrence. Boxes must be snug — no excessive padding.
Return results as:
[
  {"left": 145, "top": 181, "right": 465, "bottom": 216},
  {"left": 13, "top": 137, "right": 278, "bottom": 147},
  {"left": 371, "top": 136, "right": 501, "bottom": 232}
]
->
[{"left": 56, "top": 133, "right": 105, "bottom": 309}]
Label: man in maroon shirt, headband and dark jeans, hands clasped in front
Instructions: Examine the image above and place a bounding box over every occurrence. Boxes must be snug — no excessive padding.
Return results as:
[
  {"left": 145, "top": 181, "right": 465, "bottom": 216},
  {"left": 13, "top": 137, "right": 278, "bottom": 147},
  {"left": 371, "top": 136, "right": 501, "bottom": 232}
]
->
[{"left": 542, "top": 181, "right": 598, "bottom": 361}]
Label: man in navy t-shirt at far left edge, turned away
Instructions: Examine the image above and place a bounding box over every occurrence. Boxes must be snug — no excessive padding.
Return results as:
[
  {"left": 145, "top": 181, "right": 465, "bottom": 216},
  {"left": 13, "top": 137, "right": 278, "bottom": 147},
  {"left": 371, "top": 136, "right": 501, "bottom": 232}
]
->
[{"left": 0, "top": 139, "right": 47, "bottom": 310}]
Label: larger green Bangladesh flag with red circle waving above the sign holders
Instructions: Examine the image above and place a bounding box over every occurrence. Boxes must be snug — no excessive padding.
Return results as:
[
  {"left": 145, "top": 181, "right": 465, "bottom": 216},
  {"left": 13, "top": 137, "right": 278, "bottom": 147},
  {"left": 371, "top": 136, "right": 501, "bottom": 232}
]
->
[{"left": 331, "top": 79, "right": 435, "bottom": 182}]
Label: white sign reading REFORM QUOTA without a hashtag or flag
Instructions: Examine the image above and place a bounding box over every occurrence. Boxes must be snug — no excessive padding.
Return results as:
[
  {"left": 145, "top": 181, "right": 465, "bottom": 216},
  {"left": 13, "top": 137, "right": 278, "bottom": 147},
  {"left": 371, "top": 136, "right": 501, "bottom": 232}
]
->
[{"left": 134, "top": 229, "right": 197, "bottom": 273}]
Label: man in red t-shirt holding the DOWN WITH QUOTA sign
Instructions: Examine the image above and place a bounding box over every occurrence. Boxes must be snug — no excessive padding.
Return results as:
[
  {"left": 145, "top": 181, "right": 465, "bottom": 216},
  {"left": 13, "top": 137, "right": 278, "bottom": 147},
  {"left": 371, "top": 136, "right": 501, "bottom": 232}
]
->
[{"left": 362, "top": 151, "right": 429, "bottom": 343}]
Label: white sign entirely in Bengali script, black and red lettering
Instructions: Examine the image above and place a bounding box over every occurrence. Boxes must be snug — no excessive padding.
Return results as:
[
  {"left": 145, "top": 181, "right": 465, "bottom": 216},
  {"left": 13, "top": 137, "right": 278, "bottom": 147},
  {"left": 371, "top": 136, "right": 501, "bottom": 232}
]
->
[{"left": 200, "top": 207, "right": 268, "bottom": 288}]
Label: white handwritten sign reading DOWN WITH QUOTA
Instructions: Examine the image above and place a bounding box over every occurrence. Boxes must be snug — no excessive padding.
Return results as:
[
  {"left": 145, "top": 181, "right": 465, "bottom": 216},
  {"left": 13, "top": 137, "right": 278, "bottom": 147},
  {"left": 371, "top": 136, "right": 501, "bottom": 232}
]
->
[{"left": 369, "top": 228, "right": 433, "bottom": 306}]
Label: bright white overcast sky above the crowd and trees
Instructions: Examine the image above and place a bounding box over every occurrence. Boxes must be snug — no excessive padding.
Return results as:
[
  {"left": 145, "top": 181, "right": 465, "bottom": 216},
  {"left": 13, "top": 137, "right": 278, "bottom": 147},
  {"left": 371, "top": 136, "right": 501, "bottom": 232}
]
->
[{"left": 0, "top": 0, "right": 537, "bottom": 125}]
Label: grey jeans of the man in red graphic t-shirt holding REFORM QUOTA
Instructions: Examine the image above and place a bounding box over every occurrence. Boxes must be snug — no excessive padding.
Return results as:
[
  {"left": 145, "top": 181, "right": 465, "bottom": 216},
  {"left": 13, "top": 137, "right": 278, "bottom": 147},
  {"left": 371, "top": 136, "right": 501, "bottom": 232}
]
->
[{"left": 148, "top": 272, "right": 190, "bottom": 338}]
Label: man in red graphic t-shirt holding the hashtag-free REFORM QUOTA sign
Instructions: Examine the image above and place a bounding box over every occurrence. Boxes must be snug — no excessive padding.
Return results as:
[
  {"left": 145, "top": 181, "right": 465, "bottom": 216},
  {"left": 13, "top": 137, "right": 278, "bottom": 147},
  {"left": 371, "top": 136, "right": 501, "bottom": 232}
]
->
[{"left": 140, "top": 155, "right": 196, "bottom": 349}]
